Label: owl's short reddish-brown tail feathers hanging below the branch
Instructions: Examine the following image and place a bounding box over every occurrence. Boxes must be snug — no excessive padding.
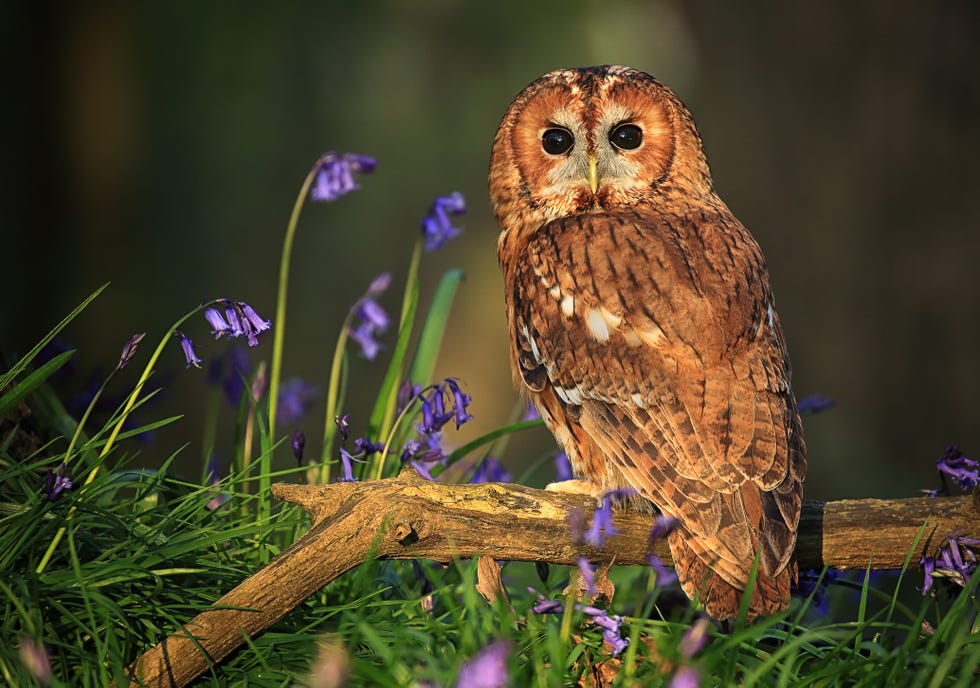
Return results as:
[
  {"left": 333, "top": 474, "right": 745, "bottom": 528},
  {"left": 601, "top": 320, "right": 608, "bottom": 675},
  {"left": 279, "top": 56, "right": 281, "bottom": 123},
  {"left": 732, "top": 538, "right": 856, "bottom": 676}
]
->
[{"left": 668, "top": 529, "right": 796, "bottom": 621}]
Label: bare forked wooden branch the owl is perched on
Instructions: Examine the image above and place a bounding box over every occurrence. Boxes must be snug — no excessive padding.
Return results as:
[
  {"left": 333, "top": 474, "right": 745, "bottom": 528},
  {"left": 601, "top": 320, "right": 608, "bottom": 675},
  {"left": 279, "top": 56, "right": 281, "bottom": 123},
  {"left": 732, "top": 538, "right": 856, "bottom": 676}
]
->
[{"left": 124, "top": 470, "right": 980, "bottom": 686}]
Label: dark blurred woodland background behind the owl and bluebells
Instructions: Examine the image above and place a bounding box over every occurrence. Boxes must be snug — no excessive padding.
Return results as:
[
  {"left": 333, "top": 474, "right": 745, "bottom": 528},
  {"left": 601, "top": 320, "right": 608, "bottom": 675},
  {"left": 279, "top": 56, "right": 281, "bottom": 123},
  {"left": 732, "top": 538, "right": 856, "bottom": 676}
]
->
[{"left": 0, "top": 0, "right": 980, "bottom": 499}]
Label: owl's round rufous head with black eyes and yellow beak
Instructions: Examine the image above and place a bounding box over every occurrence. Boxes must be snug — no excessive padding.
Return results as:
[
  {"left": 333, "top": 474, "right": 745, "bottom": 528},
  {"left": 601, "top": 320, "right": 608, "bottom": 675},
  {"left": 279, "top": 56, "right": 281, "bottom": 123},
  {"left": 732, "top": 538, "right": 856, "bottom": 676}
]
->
[{"left": 490, "top": 66, "right": 713, "bottom": 235}]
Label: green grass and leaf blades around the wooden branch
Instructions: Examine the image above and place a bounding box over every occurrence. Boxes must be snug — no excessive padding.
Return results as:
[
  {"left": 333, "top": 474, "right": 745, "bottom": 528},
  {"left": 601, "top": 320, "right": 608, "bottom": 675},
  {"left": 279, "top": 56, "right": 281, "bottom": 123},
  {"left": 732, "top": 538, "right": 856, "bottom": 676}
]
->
[{"left": 0, "top": 156, "right": 980, "bottom": 688}]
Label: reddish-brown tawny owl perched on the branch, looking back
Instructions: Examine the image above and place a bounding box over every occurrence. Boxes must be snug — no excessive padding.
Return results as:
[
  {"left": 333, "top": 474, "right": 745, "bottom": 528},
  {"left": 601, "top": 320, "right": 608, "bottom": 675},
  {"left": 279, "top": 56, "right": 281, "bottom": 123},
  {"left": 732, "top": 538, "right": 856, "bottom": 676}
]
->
[{"left": 490, "top": 66, "right": 806, "bottom": 619}]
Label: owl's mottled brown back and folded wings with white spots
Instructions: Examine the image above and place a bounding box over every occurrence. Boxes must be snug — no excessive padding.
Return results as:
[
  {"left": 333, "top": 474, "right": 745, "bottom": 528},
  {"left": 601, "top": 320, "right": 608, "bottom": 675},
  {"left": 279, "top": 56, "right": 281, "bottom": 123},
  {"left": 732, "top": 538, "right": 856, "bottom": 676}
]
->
[{"left": 505, "top": 208, "right": 805, "bottom": 585}]
